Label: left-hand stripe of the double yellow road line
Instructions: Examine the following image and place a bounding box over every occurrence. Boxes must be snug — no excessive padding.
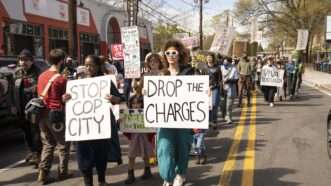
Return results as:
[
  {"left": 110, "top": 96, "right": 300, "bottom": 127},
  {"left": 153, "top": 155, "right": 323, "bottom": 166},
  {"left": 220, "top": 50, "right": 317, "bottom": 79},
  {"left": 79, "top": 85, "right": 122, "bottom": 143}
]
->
[{"left": 219, "top": 101, "right": 248, "bottom": 186}]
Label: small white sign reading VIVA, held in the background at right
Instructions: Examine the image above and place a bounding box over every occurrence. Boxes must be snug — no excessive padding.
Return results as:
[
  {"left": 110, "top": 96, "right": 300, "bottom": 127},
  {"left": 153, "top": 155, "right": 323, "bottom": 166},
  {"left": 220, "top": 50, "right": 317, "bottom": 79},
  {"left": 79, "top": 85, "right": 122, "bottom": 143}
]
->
[{"left": 261, "top": 68, "right": 284, "bottom": 87}]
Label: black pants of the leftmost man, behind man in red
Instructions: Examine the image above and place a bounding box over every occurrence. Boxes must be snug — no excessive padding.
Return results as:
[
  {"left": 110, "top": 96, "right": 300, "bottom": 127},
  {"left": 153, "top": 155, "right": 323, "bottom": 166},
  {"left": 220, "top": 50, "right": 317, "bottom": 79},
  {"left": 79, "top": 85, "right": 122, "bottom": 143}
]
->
[{"left": 20, "top": 117, "right": 42, "bottom": 154}]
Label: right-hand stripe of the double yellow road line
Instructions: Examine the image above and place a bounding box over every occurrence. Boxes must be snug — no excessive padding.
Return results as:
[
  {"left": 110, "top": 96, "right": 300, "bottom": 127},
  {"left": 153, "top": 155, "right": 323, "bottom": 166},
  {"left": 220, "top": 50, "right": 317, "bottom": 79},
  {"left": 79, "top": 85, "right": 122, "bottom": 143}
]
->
[{"left": 241, "top": 94, "right": 256, "bottom": 186}]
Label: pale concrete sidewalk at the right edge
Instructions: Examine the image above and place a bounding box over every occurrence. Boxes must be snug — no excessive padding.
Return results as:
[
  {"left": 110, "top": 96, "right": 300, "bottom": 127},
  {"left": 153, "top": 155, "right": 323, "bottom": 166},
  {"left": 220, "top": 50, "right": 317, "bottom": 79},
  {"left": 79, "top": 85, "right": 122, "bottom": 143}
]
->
[{"left": 302, "top": 68, "right": 331, "bottom": 92}]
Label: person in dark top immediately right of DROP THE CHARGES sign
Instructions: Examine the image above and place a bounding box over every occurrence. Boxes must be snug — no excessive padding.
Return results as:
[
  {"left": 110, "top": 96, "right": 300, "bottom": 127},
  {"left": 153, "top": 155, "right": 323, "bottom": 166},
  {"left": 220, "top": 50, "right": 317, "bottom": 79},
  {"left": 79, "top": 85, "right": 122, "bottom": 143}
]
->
[{"left": 207, "top": 53, "right": 222, "bottom": 129}]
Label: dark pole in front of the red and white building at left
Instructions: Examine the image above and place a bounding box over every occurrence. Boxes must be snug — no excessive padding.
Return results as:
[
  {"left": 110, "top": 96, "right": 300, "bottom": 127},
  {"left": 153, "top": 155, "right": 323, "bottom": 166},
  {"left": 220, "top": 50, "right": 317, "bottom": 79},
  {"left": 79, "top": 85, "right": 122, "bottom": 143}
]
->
[{"left": 68, "top": 0, "right": 78, "bottom": 59}]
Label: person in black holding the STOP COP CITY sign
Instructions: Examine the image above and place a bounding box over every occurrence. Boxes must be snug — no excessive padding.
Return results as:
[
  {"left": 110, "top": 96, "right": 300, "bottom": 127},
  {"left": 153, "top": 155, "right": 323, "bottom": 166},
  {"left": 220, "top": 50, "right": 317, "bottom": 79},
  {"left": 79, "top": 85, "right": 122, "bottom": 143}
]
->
[{"left": 70, "top": 55, "right": 121, "bottom": 186}]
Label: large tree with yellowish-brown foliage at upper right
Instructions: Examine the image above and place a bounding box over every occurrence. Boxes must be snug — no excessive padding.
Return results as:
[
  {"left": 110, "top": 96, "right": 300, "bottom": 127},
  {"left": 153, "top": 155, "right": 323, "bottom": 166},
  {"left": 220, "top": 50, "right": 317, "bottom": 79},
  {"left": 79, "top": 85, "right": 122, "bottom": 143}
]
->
[{"left": 235, "top": 0, "right": 331, "bottom": 61}]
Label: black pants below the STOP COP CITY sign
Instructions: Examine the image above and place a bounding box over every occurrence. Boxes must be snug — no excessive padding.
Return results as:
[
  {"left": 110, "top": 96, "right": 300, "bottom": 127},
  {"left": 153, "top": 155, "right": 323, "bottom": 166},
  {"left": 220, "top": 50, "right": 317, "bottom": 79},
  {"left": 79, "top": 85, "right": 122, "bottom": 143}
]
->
[{"left": 77, "top": 140, "right": 109, "bottom": 186}]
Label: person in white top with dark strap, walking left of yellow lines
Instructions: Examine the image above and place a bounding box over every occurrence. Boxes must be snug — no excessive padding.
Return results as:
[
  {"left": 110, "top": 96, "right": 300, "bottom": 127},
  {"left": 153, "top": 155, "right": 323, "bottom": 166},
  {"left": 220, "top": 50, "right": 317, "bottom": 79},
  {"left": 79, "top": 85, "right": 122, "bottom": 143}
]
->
[{"left": 221, "top": 58, "right": 239, "bottom": 124}]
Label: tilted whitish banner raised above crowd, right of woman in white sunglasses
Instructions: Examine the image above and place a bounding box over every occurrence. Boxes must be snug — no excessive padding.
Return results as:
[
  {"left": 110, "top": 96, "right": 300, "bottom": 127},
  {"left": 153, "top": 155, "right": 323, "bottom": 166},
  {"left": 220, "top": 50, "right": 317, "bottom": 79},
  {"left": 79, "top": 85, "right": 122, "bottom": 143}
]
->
[{"left": 210, "top": 27, "right": 236, "bottom": 56}]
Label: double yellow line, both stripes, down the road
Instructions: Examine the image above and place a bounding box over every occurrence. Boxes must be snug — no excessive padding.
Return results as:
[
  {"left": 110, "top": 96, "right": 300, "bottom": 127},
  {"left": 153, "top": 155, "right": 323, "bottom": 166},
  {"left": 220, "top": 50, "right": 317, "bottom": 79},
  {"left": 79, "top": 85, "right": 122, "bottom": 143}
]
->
[{"left": 219, "top": 94, "right": 256, "bottom": 186}]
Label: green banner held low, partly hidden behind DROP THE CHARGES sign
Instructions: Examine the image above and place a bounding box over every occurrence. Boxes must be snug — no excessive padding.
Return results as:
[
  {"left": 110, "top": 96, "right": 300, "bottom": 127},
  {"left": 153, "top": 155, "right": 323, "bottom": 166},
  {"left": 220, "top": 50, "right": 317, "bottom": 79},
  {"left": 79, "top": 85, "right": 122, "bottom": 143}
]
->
[{"left": 120, "top": 109, "right": 156, "bottom": 133}]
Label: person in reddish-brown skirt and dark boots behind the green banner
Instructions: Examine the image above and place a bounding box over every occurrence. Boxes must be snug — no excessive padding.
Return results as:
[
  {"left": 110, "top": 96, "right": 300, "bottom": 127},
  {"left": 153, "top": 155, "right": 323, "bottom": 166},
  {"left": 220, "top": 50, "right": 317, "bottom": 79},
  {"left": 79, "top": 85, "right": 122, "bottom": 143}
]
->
[{"left": 125, "top": 78, "right": 154, "bottom": 184}]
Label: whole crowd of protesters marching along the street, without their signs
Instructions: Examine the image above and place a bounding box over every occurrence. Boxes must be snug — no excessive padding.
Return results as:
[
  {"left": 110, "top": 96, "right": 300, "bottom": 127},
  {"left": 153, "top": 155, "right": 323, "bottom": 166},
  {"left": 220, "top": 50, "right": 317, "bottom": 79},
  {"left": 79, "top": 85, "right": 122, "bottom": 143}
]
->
[{"left": 15, "top": 40, "right": 304, "bottom": 186}]
